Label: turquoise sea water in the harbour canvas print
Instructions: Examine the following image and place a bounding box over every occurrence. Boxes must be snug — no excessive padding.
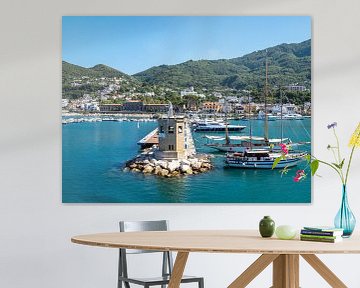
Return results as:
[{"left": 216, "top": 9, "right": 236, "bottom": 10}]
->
[{"left": 62, "top": 118, "right": 311, "bottom": 203}]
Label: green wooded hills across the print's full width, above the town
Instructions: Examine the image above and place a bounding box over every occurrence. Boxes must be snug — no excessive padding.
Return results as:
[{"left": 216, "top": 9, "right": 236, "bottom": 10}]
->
[{"left": 62, "top": 40, "right": 311, "bottom": 103}]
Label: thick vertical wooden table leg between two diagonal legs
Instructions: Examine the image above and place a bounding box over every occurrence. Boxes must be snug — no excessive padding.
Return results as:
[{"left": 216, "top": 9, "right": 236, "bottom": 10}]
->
[{"left": 272, "top": 254, "right": 299, "bottom": 288}]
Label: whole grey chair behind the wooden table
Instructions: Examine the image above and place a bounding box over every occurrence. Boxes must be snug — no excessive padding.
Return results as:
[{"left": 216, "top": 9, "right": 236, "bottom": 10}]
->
[{"left": 118, "top": 220, "right": 204, "bottom": 288}]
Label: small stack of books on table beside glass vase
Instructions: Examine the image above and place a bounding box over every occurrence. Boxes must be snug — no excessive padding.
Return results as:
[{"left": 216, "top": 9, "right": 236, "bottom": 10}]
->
[{"left": 300, "top": 227, "right": 344, "bottom": 243}]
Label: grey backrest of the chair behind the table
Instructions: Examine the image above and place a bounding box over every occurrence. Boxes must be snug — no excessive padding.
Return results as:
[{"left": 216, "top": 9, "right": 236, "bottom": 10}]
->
[{"left": 119, "top": 220, "right": 169, "bottom": 254}]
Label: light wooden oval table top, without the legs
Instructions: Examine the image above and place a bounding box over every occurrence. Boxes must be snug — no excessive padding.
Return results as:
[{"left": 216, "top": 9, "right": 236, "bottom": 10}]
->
[{"left": 71, "top": 230, "right": 360, "bottom": 254}]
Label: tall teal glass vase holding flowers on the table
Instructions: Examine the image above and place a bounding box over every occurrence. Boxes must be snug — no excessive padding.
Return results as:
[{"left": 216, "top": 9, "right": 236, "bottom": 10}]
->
[{"left": 334, "top": 185, "right": 356, "bottom": 238}]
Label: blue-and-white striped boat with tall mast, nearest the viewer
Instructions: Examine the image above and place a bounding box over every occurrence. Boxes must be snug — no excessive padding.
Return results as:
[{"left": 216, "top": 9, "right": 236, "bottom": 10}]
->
[{"left": 225, "top": 52, "right": 306, "bottom": 169}]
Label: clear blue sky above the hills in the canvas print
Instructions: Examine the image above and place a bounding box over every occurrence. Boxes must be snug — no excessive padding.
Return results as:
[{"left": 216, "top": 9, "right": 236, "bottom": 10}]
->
[{"left": 62, "top": 16, "right": 311, "bottom": 74}]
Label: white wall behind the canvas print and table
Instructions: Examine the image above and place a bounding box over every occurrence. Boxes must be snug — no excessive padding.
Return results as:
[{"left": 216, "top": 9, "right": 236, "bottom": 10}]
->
[{"left": 0, "top": 0, "right": 360, "bottom": 288}]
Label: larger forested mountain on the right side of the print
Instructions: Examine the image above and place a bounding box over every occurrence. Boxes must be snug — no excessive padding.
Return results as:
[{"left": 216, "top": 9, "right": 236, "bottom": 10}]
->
[{"left": 133, "top": 39, "right": 311, "bottom": 89}]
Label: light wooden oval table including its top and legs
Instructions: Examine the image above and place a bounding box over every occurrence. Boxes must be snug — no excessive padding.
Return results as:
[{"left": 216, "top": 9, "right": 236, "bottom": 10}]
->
[{"left": 71, "top": 230, "right": 360, "bottom": 288}]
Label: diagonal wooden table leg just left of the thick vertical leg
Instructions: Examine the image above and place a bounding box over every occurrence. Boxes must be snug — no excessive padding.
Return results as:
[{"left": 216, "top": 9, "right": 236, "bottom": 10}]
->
[{"left": 228, "top": 254, "right": 279, "bottom": 288}]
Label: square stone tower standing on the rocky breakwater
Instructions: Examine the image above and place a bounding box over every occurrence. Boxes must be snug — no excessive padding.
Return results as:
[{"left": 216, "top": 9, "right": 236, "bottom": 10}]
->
[{"left": 156, "top": 113, "right": 186, "bottom": 160}]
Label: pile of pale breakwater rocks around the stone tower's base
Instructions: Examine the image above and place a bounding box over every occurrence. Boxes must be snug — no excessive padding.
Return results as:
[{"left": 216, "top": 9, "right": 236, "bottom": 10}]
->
[{"left": 124, "top": 155, "right": 213, "bottom": 178}]
